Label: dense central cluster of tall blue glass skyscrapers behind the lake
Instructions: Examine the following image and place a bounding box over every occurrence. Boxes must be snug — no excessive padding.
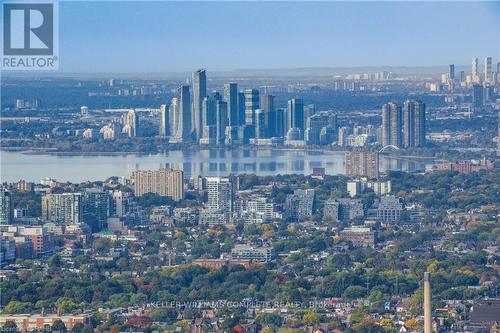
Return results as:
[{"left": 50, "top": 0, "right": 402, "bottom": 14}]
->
[{"left": 159, "top": 69, "right": 320, "bottom": 145}]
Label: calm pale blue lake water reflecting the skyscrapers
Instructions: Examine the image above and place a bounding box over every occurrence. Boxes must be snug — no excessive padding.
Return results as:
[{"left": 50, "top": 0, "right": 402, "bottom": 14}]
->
[{"left": 0, "top": 149, "right": 423, "bottom": 182}]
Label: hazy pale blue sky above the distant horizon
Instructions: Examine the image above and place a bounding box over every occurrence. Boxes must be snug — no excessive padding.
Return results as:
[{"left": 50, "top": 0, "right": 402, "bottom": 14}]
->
[{"left": 59, "top": 1, "right": 500, "bottom": 73}]
